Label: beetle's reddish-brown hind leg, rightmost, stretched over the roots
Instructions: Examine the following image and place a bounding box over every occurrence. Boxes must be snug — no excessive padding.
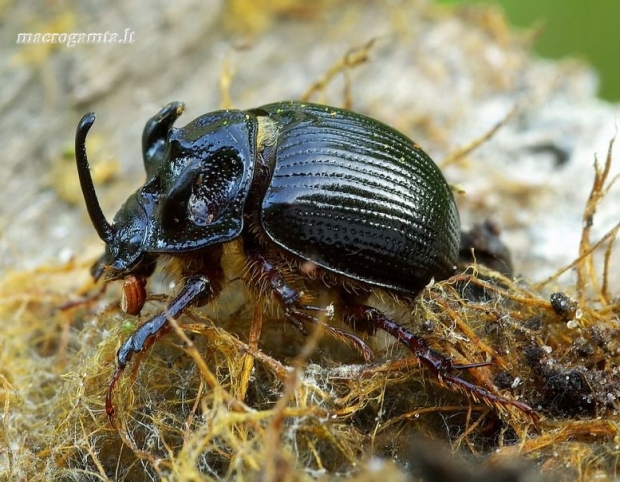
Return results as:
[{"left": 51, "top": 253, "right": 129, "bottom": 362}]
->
[{"left": 343, "top": 305, "right": 536, "bottom": 421}]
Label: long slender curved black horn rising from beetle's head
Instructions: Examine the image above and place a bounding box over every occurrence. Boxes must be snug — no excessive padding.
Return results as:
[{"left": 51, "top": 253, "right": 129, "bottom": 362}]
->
[{"left": 75, "top": 112, "right": 114, "bottom": 244}]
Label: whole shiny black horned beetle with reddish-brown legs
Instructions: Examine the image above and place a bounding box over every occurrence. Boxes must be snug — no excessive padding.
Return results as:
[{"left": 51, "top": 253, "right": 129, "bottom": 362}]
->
[{"left": 76, "top": 101, "right": 532, "bottom": 420}]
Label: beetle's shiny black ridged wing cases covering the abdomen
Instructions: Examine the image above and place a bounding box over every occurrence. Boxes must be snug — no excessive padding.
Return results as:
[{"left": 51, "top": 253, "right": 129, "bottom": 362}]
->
[{"left": 260, "top": 102, "right": 460, "bottom": 293}]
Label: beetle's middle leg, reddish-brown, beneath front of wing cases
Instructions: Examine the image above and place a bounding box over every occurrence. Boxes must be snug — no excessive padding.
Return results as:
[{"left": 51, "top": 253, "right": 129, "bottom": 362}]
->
[{"left": 255, "top": 255, "right": 373, "bottom": 361}]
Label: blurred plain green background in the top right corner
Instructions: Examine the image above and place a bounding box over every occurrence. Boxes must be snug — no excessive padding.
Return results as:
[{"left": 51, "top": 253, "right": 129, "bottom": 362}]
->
[{"left": 437, "top": 0, "right": 620, "bottom": 101}]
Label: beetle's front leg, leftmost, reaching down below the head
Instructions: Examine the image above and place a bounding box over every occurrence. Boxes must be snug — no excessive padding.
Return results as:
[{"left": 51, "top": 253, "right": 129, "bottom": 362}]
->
[{"left": 105, "top": 275, "right": 213, "bottom": 425}]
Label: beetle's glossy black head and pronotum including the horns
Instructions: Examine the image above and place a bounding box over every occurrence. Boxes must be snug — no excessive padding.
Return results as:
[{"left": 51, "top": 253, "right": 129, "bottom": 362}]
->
[{"left": 75, "top": 103, "right": 257, "bottom": 278}]
